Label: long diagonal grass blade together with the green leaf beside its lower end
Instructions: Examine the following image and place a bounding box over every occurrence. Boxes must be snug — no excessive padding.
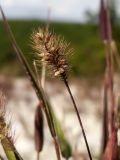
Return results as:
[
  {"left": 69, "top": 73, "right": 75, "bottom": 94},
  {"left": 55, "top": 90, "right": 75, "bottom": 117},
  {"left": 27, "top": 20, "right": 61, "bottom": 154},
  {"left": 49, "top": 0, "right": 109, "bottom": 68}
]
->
[{"left": 0, "top": 7, "right": 72, "bottom": 160}]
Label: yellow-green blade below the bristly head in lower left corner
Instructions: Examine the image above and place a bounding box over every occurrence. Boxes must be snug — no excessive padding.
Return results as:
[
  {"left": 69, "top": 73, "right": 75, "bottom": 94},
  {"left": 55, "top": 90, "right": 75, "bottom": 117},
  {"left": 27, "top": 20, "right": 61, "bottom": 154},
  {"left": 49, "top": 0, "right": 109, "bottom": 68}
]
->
[{"left": 1, "top": 137, "right": 23, "bottom": 160}]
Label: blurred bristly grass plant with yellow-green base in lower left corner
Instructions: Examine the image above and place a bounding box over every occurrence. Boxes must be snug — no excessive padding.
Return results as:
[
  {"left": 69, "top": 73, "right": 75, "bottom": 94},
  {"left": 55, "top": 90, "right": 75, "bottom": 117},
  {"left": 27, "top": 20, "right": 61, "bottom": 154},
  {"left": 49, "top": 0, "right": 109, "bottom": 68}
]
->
[{"left": 0, "top": 93, "right": 23, "bottom": 160}]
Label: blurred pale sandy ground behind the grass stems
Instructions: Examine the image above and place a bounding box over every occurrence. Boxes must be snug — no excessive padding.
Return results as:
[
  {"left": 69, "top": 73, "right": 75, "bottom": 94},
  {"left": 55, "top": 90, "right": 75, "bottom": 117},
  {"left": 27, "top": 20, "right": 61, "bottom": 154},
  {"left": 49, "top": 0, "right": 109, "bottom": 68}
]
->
[{"left": 0, "top": 77, "right": 120, "bottom": 160}]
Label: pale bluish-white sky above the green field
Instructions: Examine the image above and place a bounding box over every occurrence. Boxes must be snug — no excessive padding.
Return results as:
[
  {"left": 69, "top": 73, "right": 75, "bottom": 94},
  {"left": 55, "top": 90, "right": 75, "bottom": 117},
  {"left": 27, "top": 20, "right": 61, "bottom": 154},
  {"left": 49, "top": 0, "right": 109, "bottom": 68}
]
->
[{"left": 1, "top": 0, "right": 100, "bottom": 22}]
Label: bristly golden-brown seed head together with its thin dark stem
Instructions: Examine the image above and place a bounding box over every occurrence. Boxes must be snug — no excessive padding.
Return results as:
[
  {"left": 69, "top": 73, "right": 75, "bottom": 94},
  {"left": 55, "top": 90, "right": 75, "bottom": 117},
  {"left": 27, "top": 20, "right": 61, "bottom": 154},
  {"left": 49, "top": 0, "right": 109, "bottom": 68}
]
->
[{"left": 31, "top": 29, "right": 92, "bottom": 160}]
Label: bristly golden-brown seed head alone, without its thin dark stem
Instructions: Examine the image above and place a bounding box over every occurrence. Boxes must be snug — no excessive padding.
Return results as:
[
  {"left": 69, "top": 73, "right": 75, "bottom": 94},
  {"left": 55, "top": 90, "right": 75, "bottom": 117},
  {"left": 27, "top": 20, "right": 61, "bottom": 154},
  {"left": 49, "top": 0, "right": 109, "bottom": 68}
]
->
[{"left": 31, "top": 29, "right": 72, "bottom": 76}]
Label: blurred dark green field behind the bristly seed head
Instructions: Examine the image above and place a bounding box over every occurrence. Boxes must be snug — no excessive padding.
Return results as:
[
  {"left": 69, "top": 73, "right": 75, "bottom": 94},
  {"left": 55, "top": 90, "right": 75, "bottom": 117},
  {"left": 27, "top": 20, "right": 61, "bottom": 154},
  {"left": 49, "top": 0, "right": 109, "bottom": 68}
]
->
[{"left": 0, "top": 20, "right": 120, "bottom": 76}]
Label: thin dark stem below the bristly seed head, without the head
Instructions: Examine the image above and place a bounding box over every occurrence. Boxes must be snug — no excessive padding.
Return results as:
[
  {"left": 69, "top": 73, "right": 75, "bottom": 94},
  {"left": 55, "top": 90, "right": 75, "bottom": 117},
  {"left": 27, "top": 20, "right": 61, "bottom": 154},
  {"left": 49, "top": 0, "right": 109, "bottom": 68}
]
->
[{"left": 61, "top": 74, "right": 92, "bottom": 160}]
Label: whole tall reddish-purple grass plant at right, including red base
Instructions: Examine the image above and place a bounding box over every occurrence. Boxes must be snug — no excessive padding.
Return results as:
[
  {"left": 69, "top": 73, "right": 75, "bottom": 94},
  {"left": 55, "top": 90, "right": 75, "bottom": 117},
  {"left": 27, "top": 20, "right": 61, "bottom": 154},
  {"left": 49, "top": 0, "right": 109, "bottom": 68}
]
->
[{"left": 100, "top": 0, "right": 118, "bottom": 160}]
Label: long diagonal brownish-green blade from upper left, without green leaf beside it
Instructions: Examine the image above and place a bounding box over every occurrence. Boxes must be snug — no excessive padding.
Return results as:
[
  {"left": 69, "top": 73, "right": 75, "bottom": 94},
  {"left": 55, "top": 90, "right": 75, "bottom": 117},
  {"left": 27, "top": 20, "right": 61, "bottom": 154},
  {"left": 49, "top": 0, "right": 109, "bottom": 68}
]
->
[{"left": 0, "top": 6, "right": 60, "bottom": 160}]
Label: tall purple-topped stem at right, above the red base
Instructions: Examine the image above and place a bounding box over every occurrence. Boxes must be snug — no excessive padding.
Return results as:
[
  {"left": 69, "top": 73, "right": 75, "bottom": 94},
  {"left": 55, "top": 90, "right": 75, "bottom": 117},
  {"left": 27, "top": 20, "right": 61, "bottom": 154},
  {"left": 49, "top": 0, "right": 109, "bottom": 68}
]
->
[{"left": 100, "top": 0, "right": 115, "bottom": 134}]
